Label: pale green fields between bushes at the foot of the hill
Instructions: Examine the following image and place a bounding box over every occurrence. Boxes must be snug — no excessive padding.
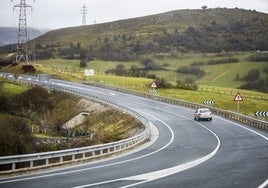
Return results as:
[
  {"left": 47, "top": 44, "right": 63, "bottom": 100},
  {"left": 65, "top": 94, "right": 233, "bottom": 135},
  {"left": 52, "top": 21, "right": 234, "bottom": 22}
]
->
[{"left": 37, "top": 52, "right": 267, "bottom": 88}]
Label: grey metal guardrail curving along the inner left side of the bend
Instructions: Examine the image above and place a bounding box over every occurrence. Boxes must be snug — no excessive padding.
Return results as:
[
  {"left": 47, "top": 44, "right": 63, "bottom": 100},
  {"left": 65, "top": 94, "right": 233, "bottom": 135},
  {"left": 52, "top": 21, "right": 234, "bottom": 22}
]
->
[{"left": 0, "top": 73, "right": 151, "bottom": 174}]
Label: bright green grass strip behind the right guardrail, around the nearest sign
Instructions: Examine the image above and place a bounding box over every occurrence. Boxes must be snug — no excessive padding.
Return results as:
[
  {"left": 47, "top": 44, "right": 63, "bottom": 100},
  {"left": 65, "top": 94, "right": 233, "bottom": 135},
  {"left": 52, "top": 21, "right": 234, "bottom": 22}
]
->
[{"left": 157, "top": 87, "right": 268, "bottom": 117}]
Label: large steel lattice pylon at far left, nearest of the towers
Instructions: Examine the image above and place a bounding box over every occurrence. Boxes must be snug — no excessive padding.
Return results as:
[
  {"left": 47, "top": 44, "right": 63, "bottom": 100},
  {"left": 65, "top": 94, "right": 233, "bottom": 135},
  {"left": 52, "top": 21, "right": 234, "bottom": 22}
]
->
[{"left": 11, "top": 0, "right": 32, "bottom": 62}]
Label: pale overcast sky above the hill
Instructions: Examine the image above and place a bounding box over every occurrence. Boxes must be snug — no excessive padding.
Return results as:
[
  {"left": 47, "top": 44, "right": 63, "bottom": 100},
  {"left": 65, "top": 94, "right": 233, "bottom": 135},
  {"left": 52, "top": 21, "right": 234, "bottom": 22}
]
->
[{"left": 0, "top": 0, "right": 268, "bottom": 29}]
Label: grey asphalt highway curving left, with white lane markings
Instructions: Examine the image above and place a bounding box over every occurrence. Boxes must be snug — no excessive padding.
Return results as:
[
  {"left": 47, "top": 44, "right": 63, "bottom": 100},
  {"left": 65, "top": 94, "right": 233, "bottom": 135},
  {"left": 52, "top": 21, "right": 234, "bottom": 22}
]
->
[{"left": 0, "top": 78, "right": 268, "bottom": 188}]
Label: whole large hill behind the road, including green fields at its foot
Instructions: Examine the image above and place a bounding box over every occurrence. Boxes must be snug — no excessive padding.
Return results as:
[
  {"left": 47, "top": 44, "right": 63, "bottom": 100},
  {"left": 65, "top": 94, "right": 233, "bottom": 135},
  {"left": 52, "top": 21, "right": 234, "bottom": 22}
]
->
[{"left": 0, "top": 8, "right": 268, "bottom": 92}]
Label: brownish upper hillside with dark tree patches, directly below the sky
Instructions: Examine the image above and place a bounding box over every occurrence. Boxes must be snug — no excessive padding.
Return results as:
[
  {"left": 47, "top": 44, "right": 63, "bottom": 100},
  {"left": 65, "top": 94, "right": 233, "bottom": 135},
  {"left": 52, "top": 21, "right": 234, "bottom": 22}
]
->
[{"left": 12, "top": 8, "right": 268, "bottom": 61}]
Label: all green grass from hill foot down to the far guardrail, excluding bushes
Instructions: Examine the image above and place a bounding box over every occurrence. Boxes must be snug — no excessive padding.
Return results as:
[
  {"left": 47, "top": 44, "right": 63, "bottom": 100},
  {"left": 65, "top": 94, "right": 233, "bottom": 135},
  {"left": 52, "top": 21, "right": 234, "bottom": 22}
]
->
[{"left": 3, "top": 52, "right": 268, "bottom": 119}]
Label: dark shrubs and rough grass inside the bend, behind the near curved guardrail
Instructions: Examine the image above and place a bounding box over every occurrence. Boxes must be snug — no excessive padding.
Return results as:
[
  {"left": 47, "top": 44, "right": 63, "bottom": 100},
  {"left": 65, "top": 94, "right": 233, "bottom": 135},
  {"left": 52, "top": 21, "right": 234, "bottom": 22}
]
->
[{"left": 0, "top": 79, "right": 143, "bottom": 156}]
